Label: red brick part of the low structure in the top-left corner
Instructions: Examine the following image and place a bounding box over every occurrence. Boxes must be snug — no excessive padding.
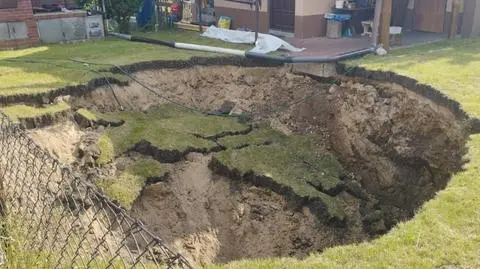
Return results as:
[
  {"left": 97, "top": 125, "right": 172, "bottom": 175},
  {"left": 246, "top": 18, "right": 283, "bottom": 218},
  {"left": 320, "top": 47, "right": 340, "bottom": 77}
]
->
[{"left": 0, "top": 0, "right": 39, "bottom": 47}]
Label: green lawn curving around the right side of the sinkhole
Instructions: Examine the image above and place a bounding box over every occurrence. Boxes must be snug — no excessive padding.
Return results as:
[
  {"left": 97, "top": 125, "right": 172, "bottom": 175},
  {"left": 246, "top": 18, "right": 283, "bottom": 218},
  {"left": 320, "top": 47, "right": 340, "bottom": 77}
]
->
[{"left": 208, "top": 39, "right": 480, "bottom": 269}]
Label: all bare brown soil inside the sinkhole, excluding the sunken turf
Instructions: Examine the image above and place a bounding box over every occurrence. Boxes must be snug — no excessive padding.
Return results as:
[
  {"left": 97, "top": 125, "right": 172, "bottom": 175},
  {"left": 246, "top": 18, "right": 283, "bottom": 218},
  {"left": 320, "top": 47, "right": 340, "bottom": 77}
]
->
[{"left": 23, "top": 63, "right": 467, "bottom": 264}]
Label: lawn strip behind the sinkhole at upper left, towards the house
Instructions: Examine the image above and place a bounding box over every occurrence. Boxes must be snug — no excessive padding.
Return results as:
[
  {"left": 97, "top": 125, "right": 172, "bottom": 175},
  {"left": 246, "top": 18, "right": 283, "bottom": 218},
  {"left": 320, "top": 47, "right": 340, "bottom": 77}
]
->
[{"left": 0, "top": 30, "right": 249, "bottom": 96}]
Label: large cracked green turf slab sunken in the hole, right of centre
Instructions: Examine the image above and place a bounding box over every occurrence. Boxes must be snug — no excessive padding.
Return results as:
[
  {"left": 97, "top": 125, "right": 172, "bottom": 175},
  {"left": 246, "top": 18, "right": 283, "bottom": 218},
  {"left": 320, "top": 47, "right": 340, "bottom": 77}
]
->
[{"left": 215, "top": 133, "right": 345, "bottom": 219}]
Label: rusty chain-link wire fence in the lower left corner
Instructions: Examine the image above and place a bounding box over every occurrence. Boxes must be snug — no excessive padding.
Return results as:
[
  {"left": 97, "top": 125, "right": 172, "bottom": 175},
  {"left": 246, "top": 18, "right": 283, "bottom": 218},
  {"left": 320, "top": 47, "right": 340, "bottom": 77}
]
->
[{"left": 0, "top": 114, "right": 192, "bottom": 268}]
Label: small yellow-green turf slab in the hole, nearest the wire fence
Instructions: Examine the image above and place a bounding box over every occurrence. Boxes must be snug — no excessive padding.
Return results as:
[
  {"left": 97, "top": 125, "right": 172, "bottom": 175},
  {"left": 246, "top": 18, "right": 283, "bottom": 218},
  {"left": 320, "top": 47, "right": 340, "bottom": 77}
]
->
[{"left": 97, "top": 157, "right": 168, "bottom": 210}]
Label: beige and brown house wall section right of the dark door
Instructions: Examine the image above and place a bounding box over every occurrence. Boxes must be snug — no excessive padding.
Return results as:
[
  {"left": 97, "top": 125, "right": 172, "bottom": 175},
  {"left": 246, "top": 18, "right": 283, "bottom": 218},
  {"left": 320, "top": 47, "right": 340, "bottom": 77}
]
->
[{"left": 295, "top": 0, "right": 335, "bottom": 38}]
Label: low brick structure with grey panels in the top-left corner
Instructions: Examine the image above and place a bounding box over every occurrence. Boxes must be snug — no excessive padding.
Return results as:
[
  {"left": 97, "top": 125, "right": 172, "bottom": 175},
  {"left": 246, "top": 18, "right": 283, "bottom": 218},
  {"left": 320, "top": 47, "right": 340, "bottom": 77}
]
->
[{"left": 0, "top": 0, "right": 104, "bottom": 48}]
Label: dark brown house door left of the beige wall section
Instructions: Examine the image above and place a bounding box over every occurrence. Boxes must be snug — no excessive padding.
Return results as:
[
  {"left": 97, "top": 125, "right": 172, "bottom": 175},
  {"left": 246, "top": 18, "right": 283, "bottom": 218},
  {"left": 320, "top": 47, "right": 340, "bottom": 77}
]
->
[{"left": 270, "top": 0, "right": 295, "bottom": 32}]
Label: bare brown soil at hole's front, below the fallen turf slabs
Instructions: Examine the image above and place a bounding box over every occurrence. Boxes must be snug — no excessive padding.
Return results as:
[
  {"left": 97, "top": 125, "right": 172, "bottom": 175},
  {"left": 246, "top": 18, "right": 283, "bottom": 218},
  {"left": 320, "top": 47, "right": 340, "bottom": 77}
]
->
[{"left": 132, "top": 153, "right": 365, "bottom": 264}]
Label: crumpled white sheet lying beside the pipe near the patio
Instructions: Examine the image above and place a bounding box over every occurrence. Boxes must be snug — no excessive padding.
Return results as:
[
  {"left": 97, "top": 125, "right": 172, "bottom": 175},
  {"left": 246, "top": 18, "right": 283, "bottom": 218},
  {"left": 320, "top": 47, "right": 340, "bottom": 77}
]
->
[{"left": 202, "top": 25, "right": 305, "bottom": 54}]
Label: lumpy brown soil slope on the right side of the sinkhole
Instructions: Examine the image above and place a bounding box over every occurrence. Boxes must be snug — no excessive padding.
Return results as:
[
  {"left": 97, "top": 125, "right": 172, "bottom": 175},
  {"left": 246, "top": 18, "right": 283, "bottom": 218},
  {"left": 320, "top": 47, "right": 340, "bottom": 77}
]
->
[{"left": 300, "top": 82, "right": 466, "bottom": 215}]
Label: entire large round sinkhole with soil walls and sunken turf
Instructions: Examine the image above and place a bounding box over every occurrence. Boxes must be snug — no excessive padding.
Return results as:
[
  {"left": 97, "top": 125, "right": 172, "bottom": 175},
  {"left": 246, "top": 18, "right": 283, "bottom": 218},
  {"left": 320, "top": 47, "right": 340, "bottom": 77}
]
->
[{"left": 6, "top": 66, "right": 467, "bottom": 264}]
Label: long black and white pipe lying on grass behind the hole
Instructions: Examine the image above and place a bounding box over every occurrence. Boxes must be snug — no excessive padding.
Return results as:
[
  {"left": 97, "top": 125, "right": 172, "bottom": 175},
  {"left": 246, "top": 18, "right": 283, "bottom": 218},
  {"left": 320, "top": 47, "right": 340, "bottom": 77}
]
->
[{"left": 109, "top": 33, "right": 376, "bottom": 63}]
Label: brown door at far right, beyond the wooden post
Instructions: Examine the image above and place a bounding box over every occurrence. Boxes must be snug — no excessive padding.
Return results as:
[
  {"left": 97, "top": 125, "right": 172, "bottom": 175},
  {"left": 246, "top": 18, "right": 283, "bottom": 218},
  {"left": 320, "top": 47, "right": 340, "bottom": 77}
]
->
[{"left": 415, "top": 0, "right": 447, "bottom": 33}]
